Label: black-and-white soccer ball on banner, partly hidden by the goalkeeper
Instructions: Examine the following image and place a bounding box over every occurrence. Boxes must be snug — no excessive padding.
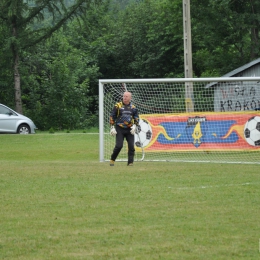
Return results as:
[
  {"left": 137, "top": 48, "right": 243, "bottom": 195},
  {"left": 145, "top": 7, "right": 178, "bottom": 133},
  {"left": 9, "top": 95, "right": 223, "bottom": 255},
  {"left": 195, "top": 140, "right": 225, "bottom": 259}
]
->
[{"left": 135, "top": 119, "right": 153, "bottom": 147}]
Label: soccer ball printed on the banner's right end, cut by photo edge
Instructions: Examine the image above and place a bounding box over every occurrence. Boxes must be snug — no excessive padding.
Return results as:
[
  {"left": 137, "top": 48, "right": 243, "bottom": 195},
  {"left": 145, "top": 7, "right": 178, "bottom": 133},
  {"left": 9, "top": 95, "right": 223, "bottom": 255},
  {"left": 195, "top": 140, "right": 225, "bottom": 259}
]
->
[{"left": 244, "top": 116, "right": 260, "bottom": 146}]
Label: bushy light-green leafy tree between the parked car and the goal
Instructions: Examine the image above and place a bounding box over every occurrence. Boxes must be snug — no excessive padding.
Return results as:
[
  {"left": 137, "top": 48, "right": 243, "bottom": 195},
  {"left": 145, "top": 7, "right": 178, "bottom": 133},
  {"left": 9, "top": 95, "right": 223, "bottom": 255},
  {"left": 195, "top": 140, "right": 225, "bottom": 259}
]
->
[{"left": 21, "top": 28, "right": 98, "bottom": 130}]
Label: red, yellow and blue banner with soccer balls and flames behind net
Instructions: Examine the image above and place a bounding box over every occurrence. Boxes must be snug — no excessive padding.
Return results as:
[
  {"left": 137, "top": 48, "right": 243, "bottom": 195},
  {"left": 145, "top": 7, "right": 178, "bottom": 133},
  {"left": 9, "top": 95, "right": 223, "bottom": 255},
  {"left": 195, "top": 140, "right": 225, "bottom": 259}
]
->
[{"left": 135, "top": 111, "right": 260, "bottom": 152}]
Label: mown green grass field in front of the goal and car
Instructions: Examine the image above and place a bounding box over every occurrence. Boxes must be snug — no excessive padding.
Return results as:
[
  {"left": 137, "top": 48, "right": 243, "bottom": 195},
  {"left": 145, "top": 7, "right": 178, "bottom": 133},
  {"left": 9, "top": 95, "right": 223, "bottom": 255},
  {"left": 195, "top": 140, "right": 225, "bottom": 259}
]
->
[{"left": 0, "top": 133, "right": 260, "bottom": 260}]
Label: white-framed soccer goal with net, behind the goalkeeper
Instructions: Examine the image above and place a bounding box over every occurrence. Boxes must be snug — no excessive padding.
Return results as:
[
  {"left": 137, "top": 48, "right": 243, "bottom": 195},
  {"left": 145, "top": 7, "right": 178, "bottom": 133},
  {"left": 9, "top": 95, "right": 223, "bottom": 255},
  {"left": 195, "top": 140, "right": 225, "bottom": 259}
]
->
[{"left": 99, "top": 77, "right": 260, "bottom": 164}]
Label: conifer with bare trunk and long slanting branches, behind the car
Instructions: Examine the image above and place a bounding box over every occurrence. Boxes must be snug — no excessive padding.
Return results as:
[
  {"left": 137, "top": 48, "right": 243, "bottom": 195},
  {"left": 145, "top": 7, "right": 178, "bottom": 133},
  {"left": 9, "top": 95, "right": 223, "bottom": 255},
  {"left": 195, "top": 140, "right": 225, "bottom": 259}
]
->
[{"left": 0, "top": 0, "right": 102, "bottom": 113}]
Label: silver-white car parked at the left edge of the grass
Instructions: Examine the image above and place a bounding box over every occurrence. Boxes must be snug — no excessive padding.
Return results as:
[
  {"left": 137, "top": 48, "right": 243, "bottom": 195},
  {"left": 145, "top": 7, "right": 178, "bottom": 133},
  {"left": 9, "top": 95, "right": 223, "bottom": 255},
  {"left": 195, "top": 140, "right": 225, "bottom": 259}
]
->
[{"left": 0, "top": 104, "right": 37, "bottom": 134}]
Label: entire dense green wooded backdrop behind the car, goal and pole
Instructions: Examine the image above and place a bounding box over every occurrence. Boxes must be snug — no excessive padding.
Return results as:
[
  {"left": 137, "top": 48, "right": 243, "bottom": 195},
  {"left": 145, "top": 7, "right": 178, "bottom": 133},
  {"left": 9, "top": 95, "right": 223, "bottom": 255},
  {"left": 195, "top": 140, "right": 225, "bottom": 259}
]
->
[{"left": 0, "top": 0, "right": 260, "bottom": 130}]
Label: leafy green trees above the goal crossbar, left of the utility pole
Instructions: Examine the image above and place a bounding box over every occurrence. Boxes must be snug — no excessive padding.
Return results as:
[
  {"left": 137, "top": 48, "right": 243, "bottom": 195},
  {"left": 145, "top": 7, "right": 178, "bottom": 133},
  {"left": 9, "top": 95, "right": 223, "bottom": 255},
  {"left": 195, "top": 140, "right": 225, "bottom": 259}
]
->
[{"left": 96, "top": 0, "right": 184, "bottom": 78}]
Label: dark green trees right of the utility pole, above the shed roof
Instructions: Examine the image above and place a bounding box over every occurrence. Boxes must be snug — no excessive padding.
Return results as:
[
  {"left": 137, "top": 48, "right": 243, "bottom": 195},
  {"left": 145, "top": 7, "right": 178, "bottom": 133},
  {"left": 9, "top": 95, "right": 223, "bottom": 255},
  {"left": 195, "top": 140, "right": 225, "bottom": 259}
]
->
[{"left": 191, "top": 0, "right": 260, "bottom": 77}]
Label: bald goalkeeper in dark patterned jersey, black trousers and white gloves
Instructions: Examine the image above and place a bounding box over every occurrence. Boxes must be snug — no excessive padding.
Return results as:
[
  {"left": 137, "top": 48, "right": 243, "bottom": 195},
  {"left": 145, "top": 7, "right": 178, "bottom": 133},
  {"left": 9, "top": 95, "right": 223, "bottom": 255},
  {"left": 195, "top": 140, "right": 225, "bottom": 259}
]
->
[{"left": 110, "top": 92, "right": 139, "bottom": 166}]
